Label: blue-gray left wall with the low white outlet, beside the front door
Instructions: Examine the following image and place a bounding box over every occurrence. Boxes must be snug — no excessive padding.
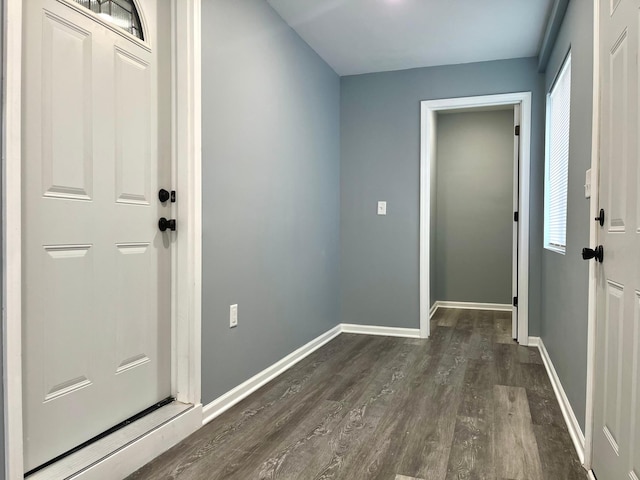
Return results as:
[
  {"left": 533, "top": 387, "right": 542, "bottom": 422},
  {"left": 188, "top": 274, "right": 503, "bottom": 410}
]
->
[{"left": 202, "top": 0, "right": 340, "bottom": 403}]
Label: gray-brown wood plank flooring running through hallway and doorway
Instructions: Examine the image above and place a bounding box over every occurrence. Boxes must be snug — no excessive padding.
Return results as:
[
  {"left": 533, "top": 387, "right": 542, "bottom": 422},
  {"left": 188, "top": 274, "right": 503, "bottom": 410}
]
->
[{"left": 129, "top": 309, "right": 587, "bottom": 480}]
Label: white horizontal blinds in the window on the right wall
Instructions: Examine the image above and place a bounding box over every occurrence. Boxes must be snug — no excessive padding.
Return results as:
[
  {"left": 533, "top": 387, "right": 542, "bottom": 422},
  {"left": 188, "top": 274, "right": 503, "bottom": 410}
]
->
[{"left": 545, "top": 54, "right": 571, "bottom": 253}]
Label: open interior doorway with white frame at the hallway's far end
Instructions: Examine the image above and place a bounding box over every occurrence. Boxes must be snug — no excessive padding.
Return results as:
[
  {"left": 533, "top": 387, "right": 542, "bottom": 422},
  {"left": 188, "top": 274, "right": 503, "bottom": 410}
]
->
[{"left": 420, "top": 92, "right": 531, "bottom": 345}]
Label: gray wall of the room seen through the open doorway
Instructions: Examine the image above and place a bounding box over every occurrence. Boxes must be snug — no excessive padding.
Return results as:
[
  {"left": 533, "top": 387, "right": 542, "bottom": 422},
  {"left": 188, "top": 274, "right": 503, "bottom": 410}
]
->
[{"left": 432, "top": 108, "right": 514, "bottom": 304}]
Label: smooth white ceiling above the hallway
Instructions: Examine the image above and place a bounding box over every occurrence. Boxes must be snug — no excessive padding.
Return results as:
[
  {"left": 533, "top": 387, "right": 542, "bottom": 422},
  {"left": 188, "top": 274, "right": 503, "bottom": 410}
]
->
[{"left": 268, "top": 0, "right": 553, "bottom": 75}]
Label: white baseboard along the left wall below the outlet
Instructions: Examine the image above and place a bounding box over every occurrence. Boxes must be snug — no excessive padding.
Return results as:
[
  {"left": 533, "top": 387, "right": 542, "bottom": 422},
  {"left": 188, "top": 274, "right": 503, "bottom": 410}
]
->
[{"left": 202, "top": 325, "right": 342, "bottom": 425}]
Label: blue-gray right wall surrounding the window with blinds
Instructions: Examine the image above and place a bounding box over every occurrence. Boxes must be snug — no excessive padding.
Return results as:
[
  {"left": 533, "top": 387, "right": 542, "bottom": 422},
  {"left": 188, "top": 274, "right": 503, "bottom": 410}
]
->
[{"left": 541, "top": 0, "right": 593, "bottom": 431}]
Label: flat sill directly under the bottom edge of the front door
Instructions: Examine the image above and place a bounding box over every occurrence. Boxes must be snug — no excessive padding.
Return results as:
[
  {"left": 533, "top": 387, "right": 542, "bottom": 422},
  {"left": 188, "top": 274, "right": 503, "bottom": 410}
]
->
[{"left": 25, "top": 401, "right": 193, "bottom": 480}]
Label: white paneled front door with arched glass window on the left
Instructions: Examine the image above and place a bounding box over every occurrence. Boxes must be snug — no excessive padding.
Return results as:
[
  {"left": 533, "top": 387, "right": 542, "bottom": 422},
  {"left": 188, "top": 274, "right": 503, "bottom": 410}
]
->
[{"left": 22, "top": 0, "right": 173, "bottom": 471}]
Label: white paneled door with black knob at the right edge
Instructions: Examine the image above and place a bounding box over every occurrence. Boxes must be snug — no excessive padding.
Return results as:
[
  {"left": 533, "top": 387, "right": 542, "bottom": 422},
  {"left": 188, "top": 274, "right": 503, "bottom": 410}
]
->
[{"left": 593, "top": 0, "right": 640, "bottom": 480}]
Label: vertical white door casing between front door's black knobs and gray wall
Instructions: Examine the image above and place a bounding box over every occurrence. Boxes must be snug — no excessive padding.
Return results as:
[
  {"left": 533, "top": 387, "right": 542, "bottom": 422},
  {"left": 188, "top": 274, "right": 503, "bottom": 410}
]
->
[{"left": 172, "top": 0, "right": 202, "bottom": 404}]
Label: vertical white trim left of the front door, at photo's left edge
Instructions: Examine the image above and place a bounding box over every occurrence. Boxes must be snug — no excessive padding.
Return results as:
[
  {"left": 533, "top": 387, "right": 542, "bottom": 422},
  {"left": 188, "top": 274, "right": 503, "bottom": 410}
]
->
[{"left": 2, "top": 0, "right": 24, "bottom": 480}]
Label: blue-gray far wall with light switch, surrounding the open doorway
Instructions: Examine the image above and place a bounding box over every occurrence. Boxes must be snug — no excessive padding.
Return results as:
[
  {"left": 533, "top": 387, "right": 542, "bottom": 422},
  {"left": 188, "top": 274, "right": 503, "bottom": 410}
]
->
[{"left": 340, "top": 58, "right": 544, "bottom": 335}]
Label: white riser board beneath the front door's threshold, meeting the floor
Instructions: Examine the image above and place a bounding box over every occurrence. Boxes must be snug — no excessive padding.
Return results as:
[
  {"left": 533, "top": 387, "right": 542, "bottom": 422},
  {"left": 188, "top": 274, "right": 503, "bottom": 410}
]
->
[{"left": 68, "top": 405, "right": 202, "bottom": 480}]
